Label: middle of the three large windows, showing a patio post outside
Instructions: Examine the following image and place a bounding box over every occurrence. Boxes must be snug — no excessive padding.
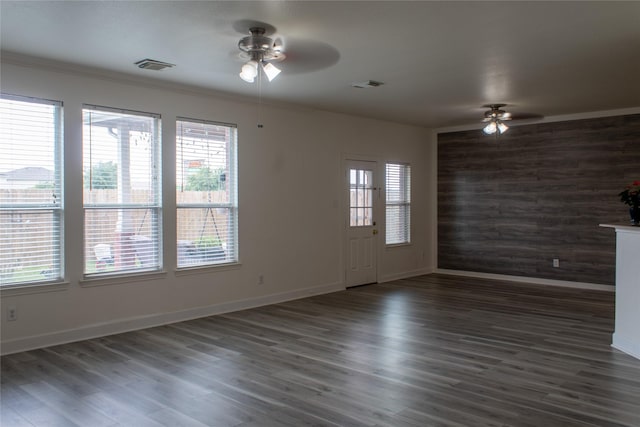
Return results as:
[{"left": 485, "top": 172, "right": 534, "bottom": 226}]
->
[{"left": 82, "top": 106, "right": 162, "bottom": 277}]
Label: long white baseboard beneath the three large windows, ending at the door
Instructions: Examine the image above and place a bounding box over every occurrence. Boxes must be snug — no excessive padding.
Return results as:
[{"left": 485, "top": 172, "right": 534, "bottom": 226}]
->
[{"left": 0, "top": 283, "right": 345, "bottom": 355}]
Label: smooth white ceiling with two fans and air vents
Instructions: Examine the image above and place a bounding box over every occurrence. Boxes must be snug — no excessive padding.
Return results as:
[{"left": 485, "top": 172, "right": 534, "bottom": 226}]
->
[{"left": 0, "top": 0, "right": 640, "bottom": 127}]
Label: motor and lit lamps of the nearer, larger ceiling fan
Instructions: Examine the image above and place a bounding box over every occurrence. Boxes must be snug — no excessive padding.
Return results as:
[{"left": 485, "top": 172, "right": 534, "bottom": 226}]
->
[{"left": 238, "top": 26, "right": 286, "bottom": 83}]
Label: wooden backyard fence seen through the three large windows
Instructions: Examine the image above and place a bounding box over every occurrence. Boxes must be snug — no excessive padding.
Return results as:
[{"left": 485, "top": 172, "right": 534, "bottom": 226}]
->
[{"left": 0, "top": 189, "right": 232, "bottom": 276}]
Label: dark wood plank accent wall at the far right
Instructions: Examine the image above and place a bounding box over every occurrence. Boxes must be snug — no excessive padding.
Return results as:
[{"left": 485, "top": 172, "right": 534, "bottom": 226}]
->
[{"left": 438, "top": 114, "right": 640, "bottom": 285}]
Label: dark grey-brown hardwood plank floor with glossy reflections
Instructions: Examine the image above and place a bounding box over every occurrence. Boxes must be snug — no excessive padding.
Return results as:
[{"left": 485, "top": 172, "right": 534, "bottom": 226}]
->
[{"left": 1, "top": 275, "right": 640, "bottom": 427}]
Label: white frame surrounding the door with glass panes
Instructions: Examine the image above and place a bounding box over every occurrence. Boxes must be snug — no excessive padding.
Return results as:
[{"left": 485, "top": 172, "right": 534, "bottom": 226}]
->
[{"left": 340, "top": 153, "right": 385, "bottom": 288}]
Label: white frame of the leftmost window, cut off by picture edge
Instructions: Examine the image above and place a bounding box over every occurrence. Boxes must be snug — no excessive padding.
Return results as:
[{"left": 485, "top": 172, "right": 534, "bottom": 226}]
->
[{"left": 0, "top": 93, "right": 66, "bottom": 290}]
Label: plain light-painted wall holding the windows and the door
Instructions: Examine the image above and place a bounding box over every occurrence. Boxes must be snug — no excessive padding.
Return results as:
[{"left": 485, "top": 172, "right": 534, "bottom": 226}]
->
[{"left": 1, "top": 59, "right": 436, "bottom": 353}]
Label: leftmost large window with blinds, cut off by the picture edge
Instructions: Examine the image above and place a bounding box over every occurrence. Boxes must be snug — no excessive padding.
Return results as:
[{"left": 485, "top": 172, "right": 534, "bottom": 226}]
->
[{"left": 0, "top": 94, "right": 64, "bottom": 285}]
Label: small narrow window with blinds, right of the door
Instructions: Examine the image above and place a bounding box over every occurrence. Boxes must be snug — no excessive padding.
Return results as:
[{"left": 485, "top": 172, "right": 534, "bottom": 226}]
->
[{"left": 386, "top": 163, "right": 411, "bottom": 245}]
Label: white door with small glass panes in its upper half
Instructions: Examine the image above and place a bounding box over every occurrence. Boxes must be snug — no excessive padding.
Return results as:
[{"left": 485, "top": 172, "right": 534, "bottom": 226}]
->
[{"left": 345, "top": 160, "right": 380, "bottom": 287}]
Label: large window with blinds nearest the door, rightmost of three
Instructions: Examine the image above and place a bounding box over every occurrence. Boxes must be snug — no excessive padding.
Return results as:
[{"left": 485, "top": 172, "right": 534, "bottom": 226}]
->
[{"left": 176, "top": 119, "right": 238, "bottom": 267}]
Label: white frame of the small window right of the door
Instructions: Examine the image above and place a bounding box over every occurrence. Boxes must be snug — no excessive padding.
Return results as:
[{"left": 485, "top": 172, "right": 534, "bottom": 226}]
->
[{"left": 384, "top": 162, "right": 412, "bottom": 247}]
